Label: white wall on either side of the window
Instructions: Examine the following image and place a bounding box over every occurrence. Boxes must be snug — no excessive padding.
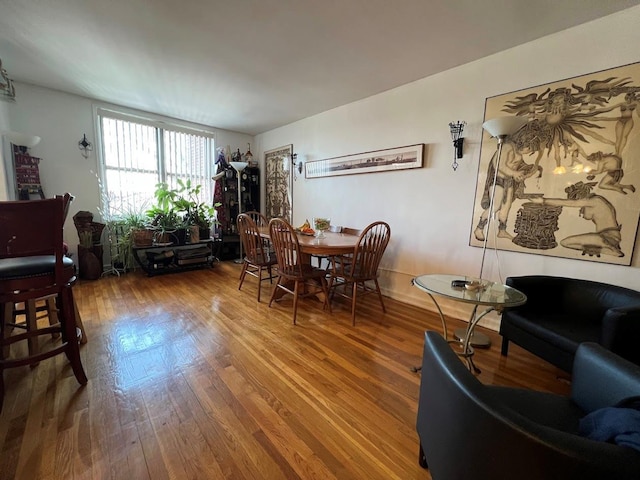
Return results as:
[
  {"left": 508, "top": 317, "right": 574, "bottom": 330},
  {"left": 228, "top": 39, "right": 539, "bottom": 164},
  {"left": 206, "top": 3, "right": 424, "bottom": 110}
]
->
[{"left": 7, "top": 83, "right": 253, "bottom": 260}]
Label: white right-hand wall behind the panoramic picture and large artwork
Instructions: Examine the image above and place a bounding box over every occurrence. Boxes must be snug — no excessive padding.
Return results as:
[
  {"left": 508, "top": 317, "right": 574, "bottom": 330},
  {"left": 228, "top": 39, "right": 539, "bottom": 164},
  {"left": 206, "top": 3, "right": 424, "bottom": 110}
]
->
[{"left": 254, "top": 7, "right": 640, "bottom": 328}]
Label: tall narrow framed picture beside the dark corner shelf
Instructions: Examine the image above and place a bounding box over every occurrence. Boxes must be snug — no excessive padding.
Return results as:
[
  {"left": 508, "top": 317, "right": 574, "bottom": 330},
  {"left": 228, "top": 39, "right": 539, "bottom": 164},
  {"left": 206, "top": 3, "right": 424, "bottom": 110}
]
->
[{"left": 264, "top": 145, "right": 293, "bottom": 222}]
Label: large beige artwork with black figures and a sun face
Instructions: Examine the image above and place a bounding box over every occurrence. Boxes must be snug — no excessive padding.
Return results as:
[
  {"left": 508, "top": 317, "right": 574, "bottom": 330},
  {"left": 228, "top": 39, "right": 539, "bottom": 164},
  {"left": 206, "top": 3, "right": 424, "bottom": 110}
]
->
[{"left": 470, "top": 63, "right": 640, "bottom": 265}]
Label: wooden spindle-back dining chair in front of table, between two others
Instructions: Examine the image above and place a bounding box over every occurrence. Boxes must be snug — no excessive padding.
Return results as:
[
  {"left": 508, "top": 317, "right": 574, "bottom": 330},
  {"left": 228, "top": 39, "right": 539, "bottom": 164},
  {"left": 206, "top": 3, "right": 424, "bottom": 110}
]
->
[{"left": 269, "top": 218, "right": 331, "bottom": 325}]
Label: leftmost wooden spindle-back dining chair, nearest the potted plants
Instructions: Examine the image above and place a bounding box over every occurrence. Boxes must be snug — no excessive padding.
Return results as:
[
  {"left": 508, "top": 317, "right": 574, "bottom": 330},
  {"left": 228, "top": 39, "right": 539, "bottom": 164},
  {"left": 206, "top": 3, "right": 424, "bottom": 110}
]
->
[{"left": 238, "top": 213, "right": 278, "bottom": 301}]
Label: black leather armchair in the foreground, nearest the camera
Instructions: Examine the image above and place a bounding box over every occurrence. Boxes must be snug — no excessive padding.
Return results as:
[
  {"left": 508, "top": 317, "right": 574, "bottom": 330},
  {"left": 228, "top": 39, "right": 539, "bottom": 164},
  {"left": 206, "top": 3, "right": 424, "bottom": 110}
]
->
[{"left": 417, "top": 332, "right": 640, "bottom": 480}]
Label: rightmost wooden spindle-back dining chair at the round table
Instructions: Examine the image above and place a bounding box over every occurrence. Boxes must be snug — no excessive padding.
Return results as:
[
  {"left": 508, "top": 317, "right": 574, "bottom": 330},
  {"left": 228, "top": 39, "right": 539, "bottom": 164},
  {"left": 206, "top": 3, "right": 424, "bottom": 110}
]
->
[{"left": 329, "top": 222, "right": 391, "bottom": 325}]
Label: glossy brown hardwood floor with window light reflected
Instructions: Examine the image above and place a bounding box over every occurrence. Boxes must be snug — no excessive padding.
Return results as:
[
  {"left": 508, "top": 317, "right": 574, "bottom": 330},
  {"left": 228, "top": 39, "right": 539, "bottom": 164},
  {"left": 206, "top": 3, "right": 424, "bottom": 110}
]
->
[{"left": 0, "top": 262, "right": 568, "bottom": 480}]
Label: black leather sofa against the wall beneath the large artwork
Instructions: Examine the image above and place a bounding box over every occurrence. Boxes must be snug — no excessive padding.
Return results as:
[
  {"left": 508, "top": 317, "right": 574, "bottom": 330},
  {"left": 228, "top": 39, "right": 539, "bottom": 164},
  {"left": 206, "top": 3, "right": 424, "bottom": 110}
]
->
[{"left": 500, "top": 275, "right": 640, "bottom": 372}]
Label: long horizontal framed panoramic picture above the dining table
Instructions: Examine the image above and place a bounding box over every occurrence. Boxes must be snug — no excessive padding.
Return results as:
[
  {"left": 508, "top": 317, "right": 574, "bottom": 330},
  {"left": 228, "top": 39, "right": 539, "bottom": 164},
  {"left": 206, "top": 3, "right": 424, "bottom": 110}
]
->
[{"left": 304, "top": 143, "right": 424, "bottom": 178}]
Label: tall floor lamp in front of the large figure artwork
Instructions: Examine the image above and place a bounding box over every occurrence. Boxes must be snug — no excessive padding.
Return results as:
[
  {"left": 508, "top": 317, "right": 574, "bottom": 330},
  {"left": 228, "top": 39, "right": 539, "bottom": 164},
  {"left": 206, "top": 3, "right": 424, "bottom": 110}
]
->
[{"left": 454, "top": 117, "right": 527, "bottom": 347}]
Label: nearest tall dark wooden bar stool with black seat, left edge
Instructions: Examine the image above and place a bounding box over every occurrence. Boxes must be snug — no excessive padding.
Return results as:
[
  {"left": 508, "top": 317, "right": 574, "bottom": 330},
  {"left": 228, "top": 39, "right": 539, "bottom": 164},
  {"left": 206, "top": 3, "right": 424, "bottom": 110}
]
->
[{"left": 0, "top": 197, "right": 87, "bottom": 411}]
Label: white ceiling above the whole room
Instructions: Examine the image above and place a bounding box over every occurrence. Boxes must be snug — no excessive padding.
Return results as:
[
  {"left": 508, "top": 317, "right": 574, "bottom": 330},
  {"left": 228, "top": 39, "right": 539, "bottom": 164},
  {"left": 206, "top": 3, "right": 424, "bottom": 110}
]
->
[{"left": 0, "top": 0, "right": 640, "bottom": 135}]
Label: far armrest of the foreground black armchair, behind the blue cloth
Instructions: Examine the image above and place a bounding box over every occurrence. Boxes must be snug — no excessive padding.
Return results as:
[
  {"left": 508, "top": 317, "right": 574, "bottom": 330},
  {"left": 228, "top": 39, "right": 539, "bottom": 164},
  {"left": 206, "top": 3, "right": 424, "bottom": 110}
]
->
[{"left": 571, "top": 342, "right": 640, "bottom": 412}]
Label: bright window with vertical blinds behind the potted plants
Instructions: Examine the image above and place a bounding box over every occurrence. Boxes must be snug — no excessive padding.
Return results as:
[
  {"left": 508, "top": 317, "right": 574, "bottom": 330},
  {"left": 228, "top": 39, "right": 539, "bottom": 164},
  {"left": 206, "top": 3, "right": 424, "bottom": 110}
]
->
[{"left": 98, "top": 109, "right": 215, "bottom": 216}]
